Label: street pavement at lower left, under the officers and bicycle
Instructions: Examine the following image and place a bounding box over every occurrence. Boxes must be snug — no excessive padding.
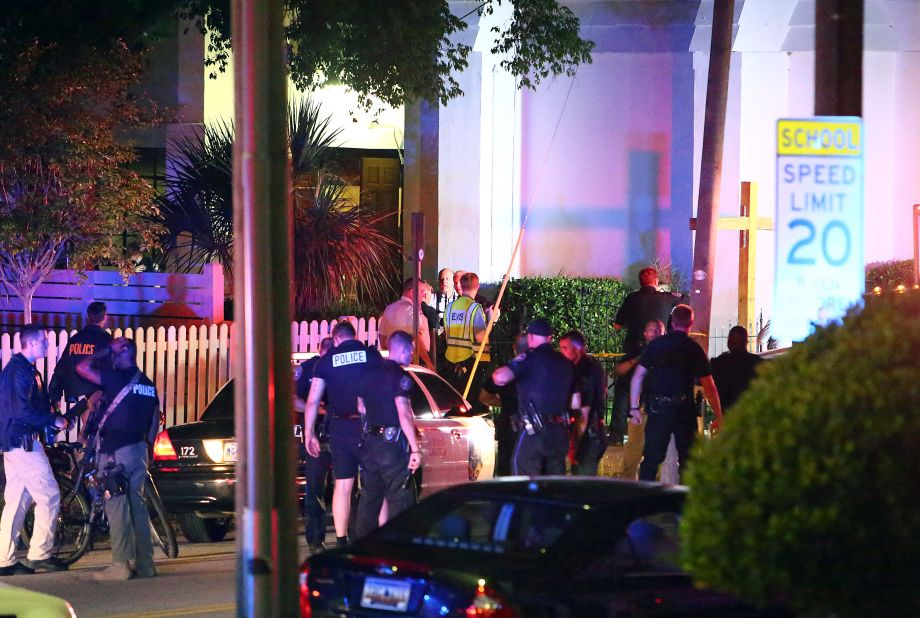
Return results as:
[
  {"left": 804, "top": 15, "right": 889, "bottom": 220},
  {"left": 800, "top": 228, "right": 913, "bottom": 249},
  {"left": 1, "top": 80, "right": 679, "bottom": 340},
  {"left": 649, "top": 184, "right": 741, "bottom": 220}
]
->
[{"left": 2, "top": 535, "right": 307, "bottom": 618}]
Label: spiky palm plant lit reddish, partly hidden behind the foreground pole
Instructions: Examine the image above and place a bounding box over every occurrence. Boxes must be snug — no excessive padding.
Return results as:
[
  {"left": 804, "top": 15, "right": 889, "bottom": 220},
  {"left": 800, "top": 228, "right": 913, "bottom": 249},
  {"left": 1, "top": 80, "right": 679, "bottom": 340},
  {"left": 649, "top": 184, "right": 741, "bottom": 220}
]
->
[{"left": 156, "top": 99, "right": 399, "bottom": 316}]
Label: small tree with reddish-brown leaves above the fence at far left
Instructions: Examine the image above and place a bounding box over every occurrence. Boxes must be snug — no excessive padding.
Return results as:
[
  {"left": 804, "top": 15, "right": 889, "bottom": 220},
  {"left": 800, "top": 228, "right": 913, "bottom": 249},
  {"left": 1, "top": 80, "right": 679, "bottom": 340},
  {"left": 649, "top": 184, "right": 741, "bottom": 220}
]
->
[{"left": 0, "top": 43, "right": 159, "bottom": 319}]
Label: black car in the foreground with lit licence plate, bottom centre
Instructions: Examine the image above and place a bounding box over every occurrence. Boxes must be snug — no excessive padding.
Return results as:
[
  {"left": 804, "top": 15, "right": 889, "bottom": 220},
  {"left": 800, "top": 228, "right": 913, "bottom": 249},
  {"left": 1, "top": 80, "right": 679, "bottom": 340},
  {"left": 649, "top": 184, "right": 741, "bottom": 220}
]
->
[{"left": 300, "top": 477, "right": 785, "bottom": 618}]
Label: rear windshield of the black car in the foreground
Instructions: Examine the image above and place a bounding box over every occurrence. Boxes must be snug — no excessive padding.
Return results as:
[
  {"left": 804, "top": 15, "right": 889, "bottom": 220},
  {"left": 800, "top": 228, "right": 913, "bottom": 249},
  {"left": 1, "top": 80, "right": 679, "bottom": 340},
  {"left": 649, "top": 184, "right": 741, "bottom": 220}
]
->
[{"left": 378, "top": 496, "right": 596, "bottom": 557}]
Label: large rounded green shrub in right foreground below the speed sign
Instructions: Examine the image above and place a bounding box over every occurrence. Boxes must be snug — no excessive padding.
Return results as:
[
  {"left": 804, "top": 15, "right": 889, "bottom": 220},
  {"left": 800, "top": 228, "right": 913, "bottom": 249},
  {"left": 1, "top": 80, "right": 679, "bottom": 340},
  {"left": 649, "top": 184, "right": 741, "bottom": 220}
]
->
[{"left": 683, "top": 293, "right": 920, "bottom": 616}]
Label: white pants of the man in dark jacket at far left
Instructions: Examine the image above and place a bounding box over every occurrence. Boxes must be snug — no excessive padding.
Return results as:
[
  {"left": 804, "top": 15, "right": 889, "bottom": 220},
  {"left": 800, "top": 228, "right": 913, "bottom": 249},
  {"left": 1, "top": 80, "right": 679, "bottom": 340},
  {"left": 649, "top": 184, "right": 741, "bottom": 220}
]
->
[{"left": 0, "top": 440, "right": 61, "bottom": 567}]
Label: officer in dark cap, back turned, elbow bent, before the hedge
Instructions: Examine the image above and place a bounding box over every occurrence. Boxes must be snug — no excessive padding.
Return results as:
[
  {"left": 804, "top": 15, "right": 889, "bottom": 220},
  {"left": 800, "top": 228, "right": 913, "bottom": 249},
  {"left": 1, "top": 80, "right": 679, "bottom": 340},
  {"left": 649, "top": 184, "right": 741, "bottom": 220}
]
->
[{"left": 492, "top": 318, "right": 574, "bottom": 476}]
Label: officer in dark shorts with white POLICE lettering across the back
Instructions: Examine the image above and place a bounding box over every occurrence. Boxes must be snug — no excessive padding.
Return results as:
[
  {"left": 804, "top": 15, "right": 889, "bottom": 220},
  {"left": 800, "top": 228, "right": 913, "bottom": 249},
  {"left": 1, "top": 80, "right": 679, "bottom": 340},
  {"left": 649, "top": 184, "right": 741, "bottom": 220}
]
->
[{"left": 304, "top": 320, "right": 381, "bottom": 547}]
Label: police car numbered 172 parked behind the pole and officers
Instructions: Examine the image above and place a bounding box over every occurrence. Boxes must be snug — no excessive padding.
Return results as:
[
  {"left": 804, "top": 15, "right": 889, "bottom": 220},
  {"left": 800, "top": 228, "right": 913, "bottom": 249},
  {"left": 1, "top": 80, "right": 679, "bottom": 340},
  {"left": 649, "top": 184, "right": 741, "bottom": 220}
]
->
[{"left": 151, "top": 366, "right": 495, "bottom": 542}]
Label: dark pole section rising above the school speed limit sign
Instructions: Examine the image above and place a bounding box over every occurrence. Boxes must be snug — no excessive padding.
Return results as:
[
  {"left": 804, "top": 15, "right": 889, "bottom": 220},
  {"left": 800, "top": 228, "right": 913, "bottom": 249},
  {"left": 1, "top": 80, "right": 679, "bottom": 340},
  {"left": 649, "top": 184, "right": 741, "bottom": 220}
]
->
[{"left": 815, "top": 0, "right": 865, "bottom": 116}]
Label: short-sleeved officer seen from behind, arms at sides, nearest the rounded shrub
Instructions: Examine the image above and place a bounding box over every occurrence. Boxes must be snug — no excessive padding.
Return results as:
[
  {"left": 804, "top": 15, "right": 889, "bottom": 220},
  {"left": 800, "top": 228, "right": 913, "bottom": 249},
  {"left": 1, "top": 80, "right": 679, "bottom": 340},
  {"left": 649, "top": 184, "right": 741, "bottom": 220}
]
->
[{"left": 630, "top": 305, "right": 722, "bottom": 481}]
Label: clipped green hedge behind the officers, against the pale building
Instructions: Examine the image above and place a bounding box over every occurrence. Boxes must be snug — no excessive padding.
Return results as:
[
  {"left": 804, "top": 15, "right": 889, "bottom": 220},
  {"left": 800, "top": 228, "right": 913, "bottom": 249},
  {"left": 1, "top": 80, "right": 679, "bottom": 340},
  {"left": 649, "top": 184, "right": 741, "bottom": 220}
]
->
[{"left": 491, "top": 277, "right": 632, "bottom": 361}]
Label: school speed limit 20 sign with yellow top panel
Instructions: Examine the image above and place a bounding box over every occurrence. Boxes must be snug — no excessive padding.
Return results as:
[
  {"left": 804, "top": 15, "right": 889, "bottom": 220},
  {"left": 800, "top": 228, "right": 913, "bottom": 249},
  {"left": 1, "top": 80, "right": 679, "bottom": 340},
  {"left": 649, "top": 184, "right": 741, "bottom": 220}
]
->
[{"left": 772, "top": 117, "right": 865, "bottom": 344}]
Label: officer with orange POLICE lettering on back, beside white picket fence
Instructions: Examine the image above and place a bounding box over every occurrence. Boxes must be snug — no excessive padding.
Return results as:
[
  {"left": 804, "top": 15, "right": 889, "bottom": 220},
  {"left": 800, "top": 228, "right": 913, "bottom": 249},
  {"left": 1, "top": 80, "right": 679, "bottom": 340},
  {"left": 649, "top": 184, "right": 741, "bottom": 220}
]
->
[{"left": 48, "top": 301, "right": 112, "bottom": 426}]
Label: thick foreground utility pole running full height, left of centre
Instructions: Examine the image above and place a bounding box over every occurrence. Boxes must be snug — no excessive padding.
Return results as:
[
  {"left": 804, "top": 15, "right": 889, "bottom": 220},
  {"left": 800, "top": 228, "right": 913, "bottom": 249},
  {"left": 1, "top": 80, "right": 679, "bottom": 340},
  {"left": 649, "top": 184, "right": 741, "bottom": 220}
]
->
[{"left": 231, "top": 0, "right": 299, "bottom": 617}]
